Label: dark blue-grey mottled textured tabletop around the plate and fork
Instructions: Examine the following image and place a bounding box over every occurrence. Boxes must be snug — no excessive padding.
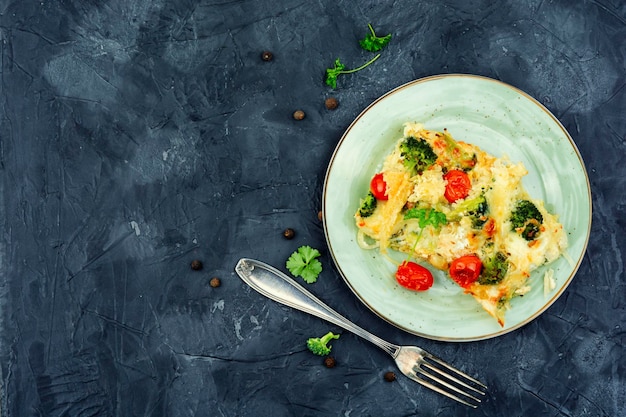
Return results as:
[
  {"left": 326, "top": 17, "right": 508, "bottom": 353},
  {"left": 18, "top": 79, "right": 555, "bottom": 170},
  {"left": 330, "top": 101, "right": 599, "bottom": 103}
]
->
[{"left": 0, "top": 0, "right": 626, "bottom": 417}]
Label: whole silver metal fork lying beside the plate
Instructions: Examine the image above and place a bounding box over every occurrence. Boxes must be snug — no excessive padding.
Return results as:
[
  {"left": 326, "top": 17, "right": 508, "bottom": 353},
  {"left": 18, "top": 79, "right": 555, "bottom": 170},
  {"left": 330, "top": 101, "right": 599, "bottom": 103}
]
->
[{"left": 235, "top": 258, "right": 487, "bottom": 408}]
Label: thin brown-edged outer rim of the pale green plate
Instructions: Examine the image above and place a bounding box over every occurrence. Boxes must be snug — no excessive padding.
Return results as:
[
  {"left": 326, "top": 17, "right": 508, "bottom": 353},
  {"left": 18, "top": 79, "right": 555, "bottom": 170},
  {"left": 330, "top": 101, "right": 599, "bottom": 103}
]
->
[{"left": 322, "top": 73, "right": 593, "bottom": 342}]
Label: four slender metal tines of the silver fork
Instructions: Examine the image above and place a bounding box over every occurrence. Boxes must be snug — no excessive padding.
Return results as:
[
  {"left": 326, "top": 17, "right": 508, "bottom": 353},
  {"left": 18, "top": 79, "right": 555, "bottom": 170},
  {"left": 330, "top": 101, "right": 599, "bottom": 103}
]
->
[{"left": 413, "top": 352, "right": 487, "bottom": 408}]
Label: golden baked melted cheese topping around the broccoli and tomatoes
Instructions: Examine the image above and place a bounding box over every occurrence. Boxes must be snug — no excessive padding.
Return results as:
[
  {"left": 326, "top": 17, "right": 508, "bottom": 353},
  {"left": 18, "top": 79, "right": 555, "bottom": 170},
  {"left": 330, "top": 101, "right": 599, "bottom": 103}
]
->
[{"left": 355, "top": 123, "right": 567, "bottom": 325}]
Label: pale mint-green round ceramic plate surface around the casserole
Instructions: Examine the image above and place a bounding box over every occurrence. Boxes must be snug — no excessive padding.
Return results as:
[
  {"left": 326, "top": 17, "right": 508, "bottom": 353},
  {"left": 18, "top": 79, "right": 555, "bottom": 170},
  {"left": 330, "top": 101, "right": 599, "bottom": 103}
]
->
[{"left": 323, "top": 75, "right": 591, "bottom": 341}]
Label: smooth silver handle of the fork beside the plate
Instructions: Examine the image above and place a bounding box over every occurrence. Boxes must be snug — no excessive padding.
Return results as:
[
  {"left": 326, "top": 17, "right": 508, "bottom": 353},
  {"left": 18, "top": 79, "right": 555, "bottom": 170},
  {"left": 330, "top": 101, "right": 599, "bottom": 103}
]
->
[{"left": 235, "top": 258, "right": 400, "bottom": 358}]
